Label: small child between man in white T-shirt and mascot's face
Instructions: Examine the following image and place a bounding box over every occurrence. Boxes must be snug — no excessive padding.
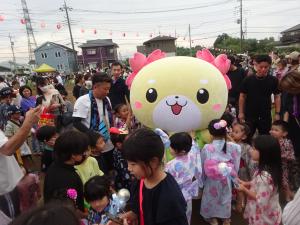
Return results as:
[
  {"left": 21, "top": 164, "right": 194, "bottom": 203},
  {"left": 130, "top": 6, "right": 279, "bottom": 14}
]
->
[{"left": 114, "top": 103, "right": 137, "bottom": 131}]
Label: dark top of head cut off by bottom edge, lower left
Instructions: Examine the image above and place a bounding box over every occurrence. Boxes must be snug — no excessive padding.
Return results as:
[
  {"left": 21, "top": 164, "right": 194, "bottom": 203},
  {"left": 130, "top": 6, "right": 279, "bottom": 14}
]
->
[{"left": 10, "top": 204, "right": 80, "bottom": 225}]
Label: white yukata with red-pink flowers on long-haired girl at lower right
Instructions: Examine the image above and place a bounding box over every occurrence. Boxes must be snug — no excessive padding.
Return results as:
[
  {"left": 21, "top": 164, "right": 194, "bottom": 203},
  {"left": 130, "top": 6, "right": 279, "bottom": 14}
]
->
[{"left": 244, "top": 171, "right": 281, "bottom": 225}]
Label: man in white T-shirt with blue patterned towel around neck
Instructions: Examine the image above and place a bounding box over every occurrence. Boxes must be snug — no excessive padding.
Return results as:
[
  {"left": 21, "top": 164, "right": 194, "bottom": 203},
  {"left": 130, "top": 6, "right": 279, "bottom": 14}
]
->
[{"left": 73, "top": 73, "right": 114, "bottom": 174}]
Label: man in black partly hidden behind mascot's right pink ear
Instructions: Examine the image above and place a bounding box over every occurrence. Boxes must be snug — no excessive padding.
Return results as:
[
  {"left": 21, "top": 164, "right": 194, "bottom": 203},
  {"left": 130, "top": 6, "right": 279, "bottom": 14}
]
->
[{"left": 227, "top": 56, "right": 246, "bottom": 108}]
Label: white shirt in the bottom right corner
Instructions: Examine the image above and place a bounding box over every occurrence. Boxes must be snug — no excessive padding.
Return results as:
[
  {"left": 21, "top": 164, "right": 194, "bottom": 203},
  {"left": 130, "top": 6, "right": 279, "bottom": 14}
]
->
[{"left": 282, "top": 188, "right": 300, "bottom": 225}]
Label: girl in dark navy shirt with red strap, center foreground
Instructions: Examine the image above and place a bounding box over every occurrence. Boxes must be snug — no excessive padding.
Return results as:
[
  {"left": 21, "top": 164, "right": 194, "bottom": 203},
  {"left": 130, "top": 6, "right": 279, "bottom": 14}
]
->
[{"left": 119, "top": 128, "right": 188, "bottom": 225}]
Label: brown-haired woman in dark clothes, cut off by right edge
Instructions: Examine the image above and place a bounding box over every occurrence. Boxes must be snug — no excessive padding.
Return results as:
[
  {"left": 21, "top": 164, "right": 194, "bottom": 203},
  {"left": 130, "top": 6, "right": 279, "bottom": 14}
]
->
[{"left": 280, "top": 70, "right": 300, "bottom": 158}]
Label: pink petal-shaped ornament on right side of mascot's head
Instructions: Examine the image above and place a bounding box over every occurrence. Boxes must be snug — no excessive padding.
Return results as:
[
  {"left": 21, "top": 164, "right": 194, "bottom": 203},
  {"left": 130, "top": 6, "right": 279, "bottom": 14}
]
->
[{"left": 196, "top": 48, "right": 231, "bottom": 90}]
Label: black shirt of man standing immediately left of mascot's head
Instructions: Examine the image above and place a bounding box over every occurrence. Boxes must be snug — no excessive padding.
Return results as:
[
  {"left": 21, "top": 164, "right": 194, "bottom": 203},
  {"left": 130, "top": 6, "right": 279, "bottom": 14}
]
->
[{"left": 108, "top": 77, "right": 129, "bottom": 109}]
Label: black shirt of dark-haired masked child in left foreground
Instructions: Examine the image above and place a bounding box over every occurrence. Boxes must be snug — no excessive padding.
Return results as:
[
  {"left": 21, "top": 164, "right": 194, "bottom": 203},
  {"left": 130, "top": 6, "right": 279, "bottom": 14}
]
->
[{"left": 44, "top": 161, "right": 84, "bottom": 211}]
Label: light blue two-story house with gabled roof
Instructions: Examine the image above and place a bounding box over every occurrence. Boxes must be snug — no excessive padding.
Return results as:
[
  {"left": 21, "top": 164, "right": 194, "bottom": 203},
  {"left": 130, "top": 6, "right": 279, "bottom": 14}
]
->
[{"left": 34, "top": 41, "right": 77, "bottom": 74}]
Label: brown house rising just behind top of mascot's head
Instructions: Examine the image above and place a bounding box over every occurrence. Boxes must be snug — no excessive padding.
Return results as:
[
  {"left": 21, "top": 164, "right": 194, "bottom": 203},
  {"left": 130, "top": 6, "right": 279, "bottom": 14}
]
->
[{"left": 137, "top": 36, "right": 177, "bottom": 56}]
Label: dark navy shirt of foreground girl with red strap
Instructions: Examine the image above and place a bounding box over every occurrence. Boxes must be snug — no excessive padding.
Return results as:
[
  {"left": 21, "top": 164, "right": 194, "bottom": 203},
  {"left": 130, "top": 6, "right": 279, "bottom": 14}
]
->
[{"left": 131, "top": 173, "right": 188, "bottom": 225}]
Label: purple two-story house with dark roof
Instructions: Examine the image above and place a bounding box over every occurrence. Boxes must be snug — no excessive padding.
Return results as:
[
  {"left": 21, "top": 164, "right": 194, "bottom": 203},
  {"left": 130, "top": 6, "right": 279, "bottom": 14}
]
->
[{"left": 78, "top": 39, "right": 119, "bottom": 69}]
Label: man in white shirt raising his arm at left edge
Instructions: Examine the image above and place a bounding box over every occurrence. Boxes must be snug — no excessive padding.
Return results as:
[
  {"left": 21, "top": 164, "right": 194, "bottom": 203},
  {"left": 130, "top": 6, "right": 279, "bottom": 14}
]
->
[{"left": 0, "top": 107, "right": 42, "bottom": 219}]
